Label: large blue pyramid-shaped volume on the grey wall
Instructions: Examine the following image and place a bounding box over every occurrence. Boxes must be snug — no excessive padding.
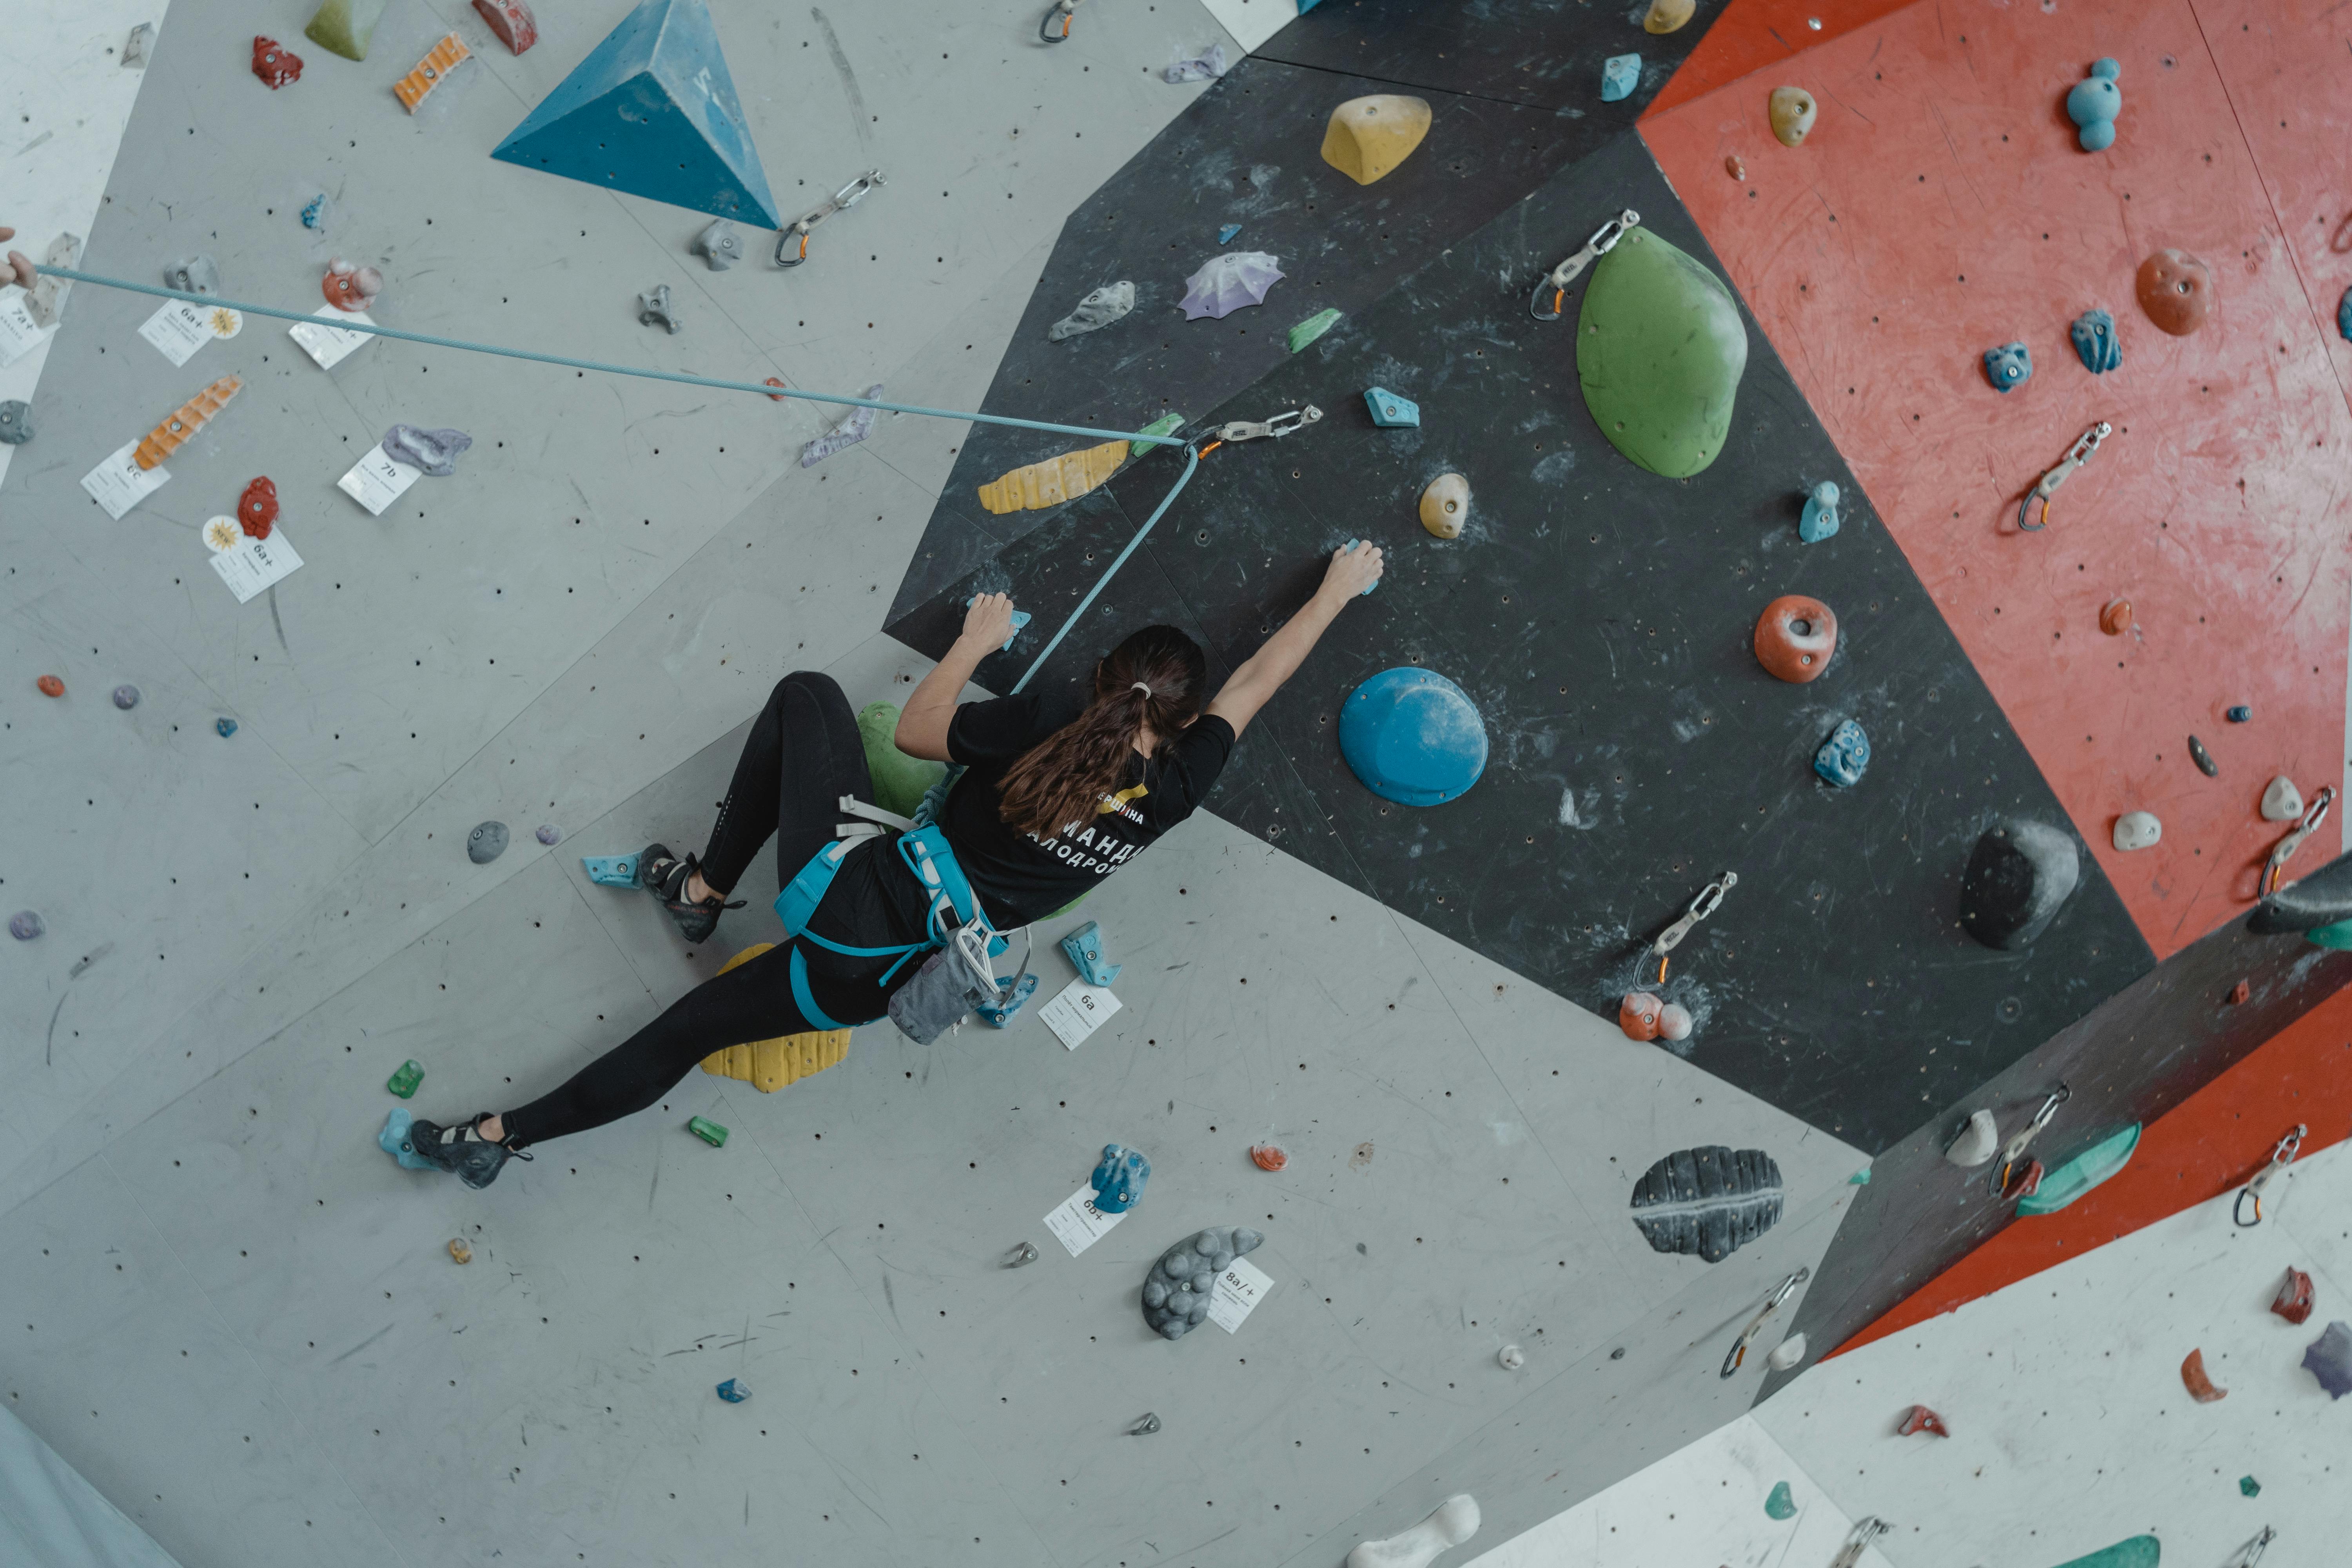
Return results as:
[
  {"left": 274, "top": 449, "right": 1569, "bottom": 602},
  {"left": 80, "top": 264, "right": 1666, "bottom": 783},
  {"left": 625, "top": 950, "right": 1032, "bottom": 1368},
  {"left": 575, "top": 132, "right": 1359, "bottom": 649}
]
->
[{"left": 492, "top": 0, "right": 783, "bottom": 228}]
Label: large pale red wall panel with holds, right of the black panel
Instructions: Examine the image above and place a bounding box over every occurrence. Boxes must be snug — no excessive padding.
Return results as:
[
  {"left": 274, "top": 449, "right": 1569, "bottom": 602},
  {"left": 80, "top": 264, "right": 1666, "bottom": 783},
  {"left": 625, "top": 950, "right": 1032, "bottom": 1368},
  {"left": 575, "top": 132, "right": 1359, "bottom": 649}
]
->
[{"left": 1642, "top": 0, "right": 2352, "bottom": 957}]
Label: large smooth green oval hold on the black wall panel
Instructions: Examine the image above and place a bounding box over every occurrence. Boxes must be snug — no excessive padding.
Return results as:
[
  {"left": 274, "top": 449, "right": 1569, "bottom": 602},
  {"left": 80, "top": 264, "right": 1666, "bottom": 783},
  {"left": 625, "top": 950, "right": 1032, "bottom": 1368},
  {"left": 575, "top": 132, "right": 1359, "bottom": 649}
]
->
[{"left": 1576, "top": 228, "right": 1748, "bottom": 479}]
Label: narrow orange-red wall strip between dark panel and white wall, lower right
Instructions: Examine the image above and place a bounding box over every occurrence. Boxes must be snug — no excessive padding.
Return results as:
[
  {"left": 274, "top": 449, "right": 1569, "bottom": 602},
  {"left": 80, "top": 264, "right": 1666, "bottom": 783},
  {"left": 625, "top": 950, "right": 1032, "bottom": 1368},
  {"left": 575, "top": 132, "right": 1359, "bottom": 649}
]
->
[{"left": 1837, "top": 968, "right": 2352, "bottom": 1352}]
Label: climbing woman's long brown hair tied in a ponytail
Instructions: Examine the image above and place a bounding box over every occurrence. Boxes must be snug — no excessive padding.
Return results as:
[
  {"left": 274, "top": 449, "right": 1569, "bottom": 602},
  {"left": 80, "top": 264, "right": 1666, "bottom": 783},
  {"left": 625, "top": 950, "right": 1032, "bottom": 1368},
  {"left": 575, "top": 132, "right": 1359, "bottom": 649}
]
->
[{"left": 997, "top": 625, "right": 1209, "bottom": 839}]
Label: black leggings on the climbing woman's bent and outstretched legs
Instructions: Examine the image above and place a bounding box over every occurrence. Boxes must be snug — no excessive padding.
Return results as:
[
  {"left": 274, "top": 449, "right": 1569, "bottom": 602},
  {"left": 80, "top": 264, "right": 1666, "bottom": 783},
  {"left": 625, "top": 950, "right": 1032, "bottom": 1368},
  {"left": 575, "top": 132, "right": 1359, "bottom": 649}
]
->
[{"left": 501, "top": 670, "right": 875, "bottom": 1147}]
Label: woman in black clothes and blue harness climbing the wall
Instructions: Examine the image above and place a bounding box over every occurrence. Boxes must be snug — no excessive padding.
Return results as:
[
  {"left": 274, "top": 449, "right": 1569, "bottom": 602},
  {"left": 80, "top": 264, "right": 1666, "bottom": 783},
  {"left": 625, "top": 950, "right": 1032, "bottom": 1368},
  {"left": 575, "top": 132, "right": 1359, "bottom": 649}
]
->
[{"left": 409, "top": 545, "right": 1381, "bottom": 1187}]
